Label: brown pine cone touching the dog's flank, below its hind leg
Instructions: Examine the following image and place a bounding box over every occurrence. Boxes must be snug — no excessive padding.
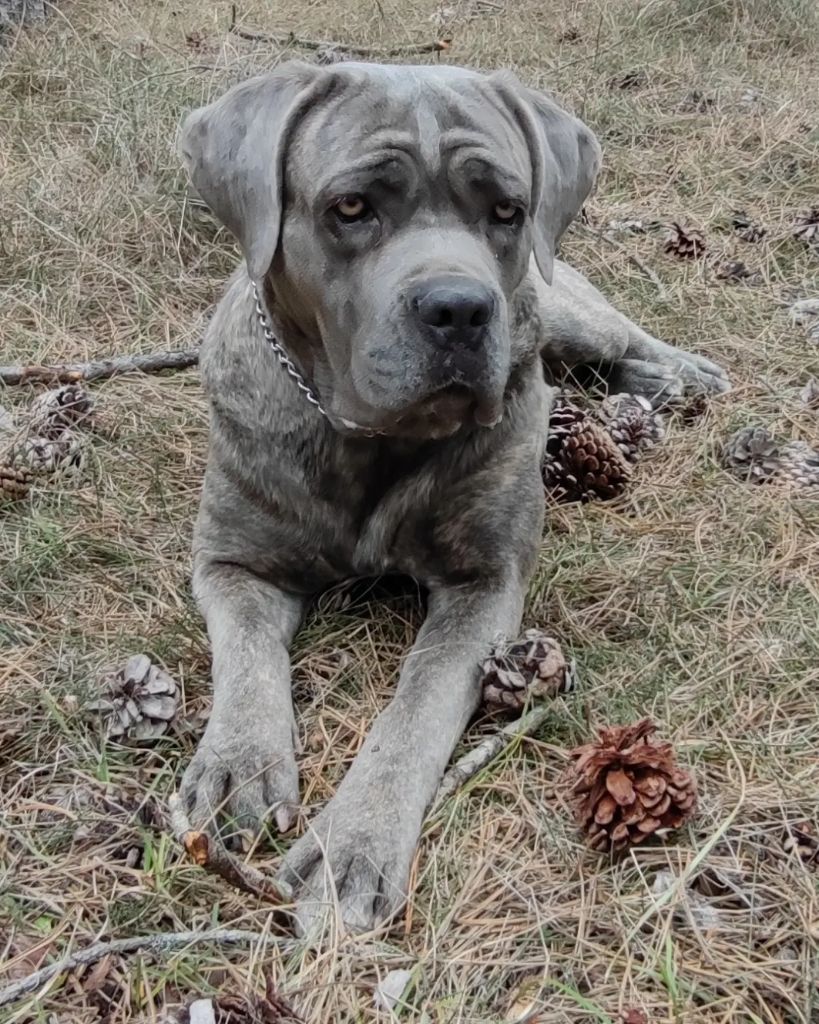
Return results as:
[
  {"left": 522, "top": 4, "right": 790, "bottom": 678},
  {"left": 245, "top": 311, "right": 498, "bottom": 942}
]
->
[{"left": 542, "top": 397, "right": 631, "bottom": 502}]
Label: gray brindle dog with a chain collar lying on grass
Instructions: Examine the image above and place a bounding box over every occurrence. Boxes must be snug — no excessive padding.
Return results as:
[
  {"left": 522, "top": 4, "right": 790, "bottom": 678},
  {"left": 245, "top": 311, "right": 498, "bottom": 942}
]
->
[{"left": 180, "top": 63, "right": 728, "bottom": 929}]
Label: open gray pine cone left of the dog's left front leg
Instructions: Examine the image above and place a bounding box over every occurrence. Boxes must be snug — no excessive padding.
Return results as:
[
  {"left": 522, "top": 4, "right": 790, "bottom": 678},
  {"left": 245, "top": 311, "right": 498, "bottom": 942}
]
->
[{"left": 87, "top": 654, "right": 179, "bottom": 740}]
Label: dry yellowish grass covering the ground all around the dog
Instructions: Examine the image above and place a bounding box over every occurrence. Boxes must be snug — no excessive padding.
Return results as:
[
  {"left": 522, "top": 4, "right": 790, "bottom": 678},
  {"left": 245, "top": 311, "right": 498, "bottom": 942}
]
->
[{"left": 0, "top": 0, "right": 819, "bottom": 1024}]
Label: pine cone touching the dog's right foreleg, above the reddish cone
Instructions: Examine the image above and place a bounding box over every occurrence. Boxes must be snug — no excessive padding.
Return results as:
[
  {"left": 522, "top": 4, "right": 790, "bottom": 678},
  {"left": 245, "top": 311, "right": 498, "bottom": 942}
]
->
[{"left": 482, "top": 630, "right": 574, "bottom": 711}]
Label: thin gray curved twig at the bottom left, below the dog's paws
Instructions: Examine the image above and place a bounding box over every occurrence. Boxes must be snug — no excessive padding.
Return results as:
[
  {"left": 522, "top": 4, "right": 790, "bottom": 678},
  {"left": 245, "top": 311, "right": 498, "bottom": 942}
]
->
[{"left": 0, "top": 928, "right": 287, "bottom": 1007}]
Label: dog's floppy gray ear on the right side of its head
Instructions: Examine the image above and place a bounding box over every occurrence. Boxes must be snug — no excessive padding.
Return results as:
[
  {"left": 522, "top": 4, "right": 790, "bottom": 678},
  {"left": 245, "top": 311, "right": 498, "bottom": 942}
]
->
[{"left": 492, "top": 72, "right": 602, "bottom": 284}]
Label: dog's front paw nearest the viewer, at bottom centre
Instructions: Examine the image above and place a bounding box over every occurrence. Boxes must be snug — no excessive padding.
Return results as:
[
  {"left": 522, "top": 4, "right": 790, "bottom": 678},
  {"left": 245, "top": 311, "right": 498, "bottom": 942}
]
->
[{"left": 278, "top": 804, "right": 416, "bottom": 937}]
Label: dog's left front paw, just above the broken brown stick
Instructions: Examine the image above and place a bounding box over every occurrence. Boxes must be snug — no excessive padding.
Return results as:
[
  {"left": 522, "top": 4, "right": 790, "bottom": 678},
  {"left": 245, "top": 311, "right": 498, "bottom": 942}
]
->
[{"left": 181, "top": 721, "right": 299, "bottom": 831}]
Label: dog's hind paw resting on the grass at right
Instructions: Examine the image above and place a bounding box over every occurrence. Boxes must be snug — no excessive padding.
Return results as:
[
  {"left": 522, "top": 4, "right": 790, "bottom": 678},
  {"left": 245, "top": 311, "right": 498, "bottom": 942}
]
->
[{"left": 607, "top": 347, "right": 731, "bottom": 407}]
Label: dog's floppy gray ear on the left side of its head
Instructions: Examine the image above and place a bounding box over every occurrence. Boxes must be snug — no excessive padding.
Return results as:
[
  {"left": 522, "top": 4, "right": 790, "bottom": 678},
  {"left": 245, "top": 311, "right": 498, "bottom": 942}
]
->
[{"left": 177, "top": 61, "right": 328, "bottom": 281}]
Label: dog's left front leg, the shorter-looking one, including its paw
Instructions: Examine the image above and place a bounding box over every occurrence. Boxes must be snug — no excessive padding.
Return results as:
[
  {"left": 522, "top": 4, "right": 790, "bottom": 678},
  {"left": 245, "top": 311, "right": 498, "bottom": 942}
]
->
[{"left": 182, "top": 563, "right": 304, "bottom": 830}]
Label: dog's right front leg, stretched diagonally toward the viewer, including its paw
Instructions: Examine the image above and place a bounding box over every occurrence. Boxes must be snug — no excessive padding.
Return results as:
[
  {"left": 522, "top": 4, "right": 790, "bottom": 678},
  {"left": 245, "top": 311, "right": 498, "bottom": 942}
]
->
[{"left": 281, "top": 575, "right": 523, "bottom": 932}]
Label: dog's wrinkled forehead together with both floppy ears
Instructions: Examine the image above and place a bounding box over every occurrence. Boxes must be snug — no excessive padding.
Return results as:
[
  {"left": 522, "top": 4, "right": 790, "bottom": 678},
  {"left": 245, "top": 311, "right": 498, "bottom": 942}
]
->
[{"left": 179, "top": 61, "right": 600, "bottom": 281}]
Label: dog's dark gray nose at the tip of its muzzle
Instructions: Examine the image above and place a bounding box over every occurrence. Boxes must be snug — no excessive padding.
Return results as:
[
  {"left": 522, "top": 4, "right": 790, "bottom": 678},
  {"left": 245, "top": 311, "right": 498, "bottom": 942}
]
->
[{"left": 412, "top": 274, "right": 494, "bottom": 346}]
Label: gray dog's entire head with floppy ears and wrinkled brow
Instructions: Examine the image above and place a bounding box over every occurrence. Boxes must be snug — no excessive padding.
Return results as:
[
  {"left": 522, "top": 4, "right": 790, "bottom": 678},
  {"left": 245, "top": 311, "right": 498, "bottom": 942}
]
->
[{"left": 180, "top": 62, "right": 600, "bottom": 437}]
